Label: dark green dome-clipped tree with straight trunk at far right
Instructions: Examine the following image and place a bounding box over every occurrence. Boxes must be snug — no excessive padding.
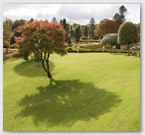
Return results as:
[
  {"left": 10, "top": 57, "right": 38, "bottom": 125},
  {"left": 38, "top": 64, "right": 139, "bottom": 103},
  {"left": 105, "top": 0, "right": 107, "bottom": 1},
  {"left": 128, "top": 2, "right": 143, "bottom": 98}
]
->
[{"left": 118, "top": 22, "right": 138, "bottom": 56}]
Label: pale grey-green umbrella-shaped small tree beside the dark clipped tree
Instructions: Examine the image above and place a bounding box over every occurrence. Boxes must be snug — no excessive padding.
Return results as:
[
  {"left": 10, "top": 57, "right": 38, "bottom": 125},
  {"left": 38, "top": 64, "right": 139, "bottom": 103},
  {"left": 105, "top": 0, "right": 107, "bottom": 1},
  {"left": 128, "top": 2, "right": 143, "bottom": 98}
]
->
[{"left": 101, "top": 33, "right": 117, "bottom": 53}]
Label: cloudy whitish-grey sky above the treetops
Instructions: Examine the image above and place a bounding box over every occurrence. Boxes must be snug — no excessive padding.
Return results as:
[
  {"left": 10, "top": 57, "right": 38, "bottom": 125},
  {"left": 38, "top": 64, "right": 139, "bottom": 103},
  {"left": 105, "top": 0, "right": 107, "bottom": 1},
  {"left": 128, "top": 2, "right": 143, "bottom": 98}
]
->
[{"left": 3, "top": 4, "right": 140, "bottom": 24}]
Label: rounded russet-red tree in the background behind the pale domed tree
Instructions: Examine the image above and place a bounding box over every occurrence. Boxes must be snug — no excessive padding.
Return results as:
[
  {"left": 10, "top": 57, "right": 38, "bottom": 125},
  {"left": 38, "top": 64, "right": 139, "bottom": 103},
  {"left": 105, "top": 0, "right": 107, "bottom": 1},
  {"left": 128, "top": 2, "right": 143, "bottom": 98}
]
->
[{"left": 94, "top": 19, "right": 118, "bottom": 37}]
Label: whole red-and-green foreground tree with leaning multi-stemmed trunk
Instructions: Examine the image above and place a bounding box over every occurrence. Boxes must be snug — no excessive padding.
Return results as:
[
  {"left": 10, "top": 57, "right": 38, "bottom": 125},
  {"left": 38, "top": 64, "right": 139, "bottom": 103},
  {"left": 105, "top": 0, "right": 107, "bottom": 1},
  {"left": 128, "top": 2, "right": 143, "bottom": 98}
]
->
[{"left": 16, "top": 21, "right": 66, "bottom": 83}]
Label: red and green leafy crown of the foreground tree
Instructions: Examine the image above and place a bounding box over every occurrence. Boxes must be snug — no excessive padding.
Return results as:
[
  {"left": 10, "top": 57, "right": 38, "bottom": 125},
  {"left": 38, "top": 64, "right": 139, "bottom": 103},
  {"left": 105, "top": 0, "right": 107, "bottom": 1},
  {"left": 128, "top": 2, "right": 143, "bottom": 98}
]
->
[{"left": 15, "top": 20, "right": 66, "bottom": 54}]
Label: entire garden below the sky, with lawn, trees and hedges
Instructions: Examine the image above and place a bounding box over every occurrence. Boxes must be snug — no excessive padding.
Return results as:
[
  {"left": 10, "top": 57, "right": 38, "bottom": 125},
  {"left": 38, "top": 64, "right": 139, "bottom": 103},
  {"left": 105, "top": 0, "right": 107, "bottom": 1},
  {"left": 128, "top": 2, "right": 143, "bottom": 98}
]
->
[{"left": 3, "top": 6, "right": 140, "bottom": 131}]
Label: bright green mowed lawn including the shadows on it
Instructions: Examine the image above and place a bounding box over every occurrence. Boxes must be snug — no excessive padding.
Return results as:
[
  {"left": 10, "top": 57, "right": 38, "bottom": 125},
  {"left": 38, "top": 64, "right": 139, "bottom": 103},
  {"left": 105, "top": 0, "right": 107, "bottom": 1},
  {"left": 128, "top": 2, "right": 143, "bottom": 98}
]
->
[{"left": 3, "top": 53, "right": 140, "bottom": 131}]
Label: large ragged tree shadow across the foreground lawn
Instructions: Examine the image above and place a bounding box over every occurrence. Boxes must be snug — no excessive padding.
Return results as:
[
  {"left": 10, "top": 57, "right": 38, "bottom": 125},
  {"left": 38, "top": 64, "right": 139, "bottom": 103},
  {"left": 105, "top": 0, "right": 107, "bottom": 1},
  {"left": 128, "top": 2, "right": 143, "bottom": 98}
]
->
[{"left": 16, "top": 80, "right": 121, "bottom": 127}]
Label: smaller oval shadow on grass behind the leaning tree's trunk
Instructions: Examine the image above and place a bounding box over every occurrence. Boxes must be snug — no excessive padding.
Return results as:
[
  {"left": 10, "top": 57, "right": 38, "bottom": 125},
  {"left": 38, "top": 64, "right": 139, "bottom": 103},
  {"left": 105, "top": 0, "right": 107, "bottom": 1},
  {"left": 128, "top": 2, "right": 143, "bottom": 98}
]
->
[{"left": 13, "top": 60, "right": 55, "bottom": 77}]
